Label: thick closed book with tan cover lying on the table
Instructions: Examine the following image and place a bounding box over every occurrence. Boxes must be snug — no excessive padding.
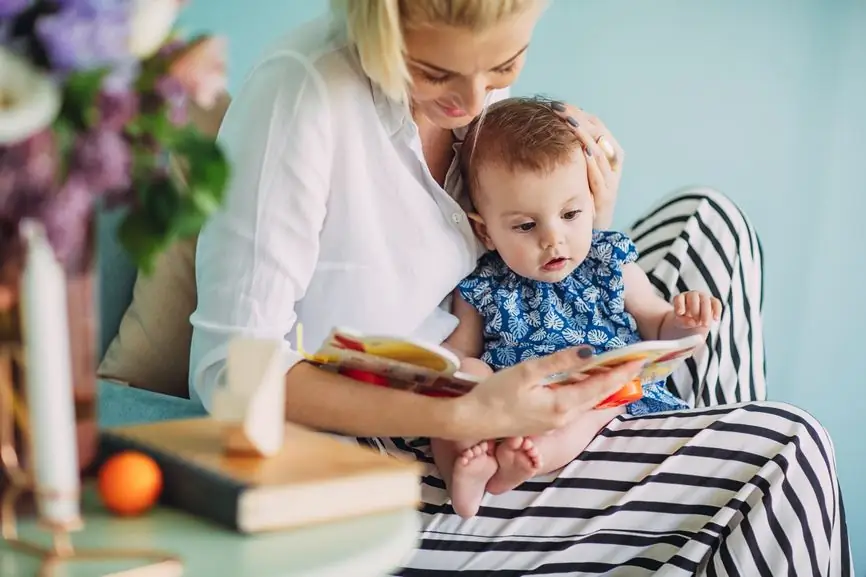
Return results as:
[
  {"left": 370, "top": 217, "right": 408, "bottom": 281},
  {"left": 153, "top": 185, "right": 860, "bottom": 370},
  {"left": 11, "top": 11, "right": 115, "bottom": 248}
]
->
[{"left": 99, "top": 417, "right": 421, "bottom": 533}]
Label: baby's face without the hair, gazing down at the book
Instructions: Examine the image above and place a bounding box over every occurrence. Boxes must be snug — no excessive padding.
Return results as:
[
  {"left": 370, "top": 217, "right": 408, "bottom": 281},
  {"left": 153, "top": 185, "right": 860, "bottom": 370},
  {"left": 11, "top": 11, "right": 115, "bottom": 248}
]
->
[{"left": 475, "top": 149, "right": 594, "bottom": 282}]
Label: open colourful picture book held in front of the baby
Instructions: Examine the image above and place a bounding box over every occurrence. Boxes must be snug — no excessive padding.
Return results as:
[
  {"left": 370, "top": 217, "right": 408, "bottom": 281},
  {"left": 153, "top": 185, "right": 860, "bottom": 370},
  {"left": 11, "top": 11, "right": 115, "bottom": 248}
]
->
[{"left": 297, "top": 327, "right": 704, "bottom": 408}]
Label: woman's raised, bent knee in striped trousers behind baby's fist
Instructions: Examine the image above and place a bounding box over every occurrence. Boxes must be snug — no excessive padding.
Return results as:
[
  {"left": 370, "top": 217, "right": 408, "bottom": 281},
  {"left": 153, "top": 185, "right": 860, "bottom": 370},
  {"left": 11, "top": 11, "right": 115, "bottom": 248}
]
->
[{"left": 629, "top": 189, "right": 767, "bottom": 407}]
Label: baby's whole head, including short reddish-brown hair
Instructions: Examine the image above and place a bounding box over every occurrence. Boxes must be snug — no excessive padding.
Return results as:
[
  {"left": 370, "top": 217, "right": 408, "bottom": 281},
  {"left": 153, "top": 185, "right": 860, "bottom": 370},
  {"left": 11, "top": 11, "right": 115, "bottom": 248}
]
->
[{"left": 460, "top": 98, "right": 595, "bottom": 282}]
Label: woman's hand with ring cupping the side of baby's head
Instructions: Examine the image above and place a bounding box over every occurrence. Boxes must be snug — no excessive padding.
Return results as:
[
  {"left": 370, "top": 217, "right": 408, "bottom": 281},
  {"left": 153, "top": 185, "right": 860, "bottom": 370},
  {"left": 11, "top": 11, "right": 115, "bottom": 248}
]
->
[{"left": 551, "top": 102, "right": 625, "bottom": 228}]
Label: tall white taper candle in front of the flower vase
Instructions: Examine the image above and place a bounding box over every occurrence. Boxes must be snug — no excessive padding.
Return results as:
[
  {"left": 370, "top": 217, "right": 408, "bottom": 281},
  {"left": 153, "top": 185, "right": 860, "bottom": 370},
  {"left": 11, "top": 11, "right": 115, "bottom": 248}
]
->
[{"left": 21, "top": 221, "right": 80, "bottom": 529}]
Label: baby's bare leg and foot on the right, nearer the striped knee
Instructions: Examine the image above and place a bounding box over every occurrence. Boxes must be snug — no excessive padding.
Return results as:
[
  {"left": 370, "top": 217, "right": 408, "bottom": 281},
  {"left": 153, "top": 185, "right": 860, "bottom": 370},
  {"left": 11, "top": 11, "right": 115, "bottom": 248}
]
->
[{"left": 487, "top": 407, "right": 625, "bottom": 495}]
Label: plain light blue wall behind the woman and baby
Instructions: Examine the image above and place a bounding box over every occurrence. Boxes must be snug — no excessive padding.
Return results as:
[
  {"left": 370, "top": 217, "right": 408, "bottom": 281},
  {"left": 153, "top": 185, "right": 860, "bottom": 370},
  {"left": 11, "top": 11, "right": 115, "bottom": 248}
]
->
[{"left": 179, "top": 0, "right": 866, "bottom": 570}]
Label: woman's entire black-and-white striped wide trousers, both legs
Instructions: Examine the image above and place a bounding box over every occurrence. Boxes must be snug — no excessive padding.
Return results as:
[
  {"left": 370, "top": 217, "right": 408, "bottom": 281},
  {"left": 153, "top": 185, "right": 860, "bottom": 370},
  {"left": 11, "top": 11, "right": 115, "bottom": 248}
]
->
[{"left": 364, "top": 190, "right": 853, "bottom": 577}]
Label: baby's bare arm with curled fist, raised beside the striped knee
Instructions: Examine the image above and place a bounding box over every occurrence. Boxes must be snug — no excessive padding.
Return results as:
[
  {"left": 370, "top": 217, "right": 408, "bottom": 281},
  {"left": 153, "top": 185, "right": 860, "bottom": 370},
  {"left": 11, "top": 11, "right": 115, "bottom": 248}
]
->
[{"left": 622, "top": 263, "right": 721, "bottom": 340}]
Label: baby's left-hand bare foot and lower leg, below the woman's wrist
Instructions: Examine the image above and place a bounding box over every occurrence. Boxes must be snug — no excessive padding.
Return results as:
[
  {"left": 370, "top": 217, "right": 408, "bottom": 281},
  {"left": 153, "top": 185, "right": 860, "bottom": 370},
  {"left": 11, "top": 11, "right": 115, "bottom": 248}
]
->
[{"left": 430, "top": 439, "right": 498, "bottom": 519}]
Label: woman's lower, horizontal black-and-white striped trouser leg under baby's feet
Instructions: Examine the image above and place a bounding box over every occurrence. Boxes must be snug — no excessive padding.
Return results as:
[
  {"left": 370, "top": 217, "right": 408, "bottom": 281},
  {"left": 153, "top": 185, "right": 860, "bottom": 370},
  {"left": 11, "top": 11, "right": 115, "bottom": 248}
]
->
[{"left": 382, "top": 403, "right": 850, "bottom": 576}]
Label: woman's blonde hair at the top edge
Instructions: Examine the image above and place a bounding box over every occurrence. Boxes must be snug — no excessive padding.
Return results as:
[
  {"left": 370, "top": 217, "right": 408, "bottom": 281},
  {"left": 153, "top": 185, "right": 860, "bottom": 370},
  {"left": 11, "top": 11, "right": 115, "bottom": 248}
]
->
[{"left": 331, "top": 0, "right": 541, "bottom": 102}]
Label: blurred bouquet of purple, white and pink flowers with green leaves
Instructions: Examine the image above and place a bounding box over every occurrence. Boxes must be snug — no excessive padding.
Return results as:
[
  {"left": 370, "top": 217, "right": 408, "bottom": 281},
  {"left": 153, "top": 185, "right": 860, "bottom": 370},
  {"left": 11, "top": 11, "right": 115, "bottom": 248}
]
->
[{"left": 0, "top": 0, "right": 228, "bottom": 274}]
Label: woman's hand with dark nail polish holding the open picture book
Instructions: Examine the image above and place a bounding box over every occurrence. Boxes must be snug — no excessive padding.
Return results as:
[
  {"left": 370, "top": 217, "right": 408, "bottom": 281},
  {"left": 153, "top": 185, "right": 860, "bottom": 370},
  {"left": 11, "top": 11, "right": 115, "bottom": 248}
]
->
[{"left": 449, "top": 347, "right": 643, "bottom": 440}]
